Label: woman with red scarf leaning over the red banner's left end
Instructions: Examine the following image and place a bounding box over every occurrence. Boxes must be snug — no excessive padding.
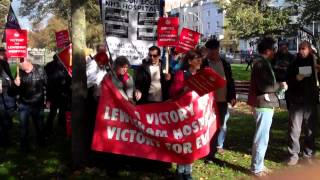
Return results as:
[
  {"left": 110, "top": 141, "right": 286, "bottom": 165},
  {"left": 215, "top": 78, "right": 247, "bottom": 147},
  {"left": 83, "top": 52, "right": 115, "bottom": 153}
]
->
[{"left": 110, "top": 56, "right": 134, "bottom": 103}]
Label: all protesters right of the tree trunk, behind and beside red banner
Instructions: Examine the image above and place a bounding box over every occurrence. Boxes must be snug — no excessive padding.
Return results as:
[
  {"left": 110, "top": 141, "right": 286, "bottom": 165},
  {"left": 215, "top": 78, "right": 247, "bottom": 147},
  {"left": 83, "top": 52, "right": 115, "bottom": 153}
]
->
[{"left": 87, "top": 38, "right": 320, "bottom": 179}]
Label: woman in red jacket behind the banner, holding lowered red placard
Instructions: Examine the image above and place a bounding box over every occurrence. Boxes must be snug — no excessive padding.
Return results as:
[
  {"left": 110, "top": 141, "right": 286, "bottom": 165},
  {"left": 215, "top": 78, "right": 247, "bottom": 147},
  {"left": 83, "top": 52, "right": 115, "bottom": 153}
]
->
[{"left": 169, "top": 50, "right": 202, "bottom": 180}]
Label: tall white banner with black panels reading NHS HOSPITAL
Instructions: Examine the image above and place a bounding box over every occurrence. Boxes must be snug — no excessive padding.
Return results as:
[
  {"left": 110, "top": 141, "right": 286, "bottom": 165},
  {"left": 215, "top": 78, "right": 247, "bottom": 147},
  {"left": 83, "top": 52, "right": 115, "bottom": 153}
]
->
[{"left": 101, "top": 0, "right": 160, "bottom": 65}]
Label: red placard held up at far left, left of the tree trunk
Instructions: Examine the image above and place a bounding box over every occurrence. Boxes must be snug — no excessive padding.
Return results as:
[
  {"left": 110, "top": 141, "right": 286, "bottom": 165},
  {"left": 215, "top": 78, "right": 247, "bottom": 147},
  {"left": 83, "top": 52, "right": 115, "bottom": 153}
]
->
[{"left": 6, "top": 29, "right": 28, "bottom": 58}]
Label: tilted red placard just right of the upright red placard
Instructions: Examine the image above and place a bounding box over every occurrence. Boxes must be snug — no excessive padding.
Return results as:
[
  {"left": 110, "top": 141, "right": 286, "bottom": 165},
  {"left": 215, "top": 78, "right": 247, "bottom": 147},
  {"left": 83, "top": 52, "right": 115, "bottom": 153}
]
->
[{"left": 177, "top": 28, "right": 201, "bottom": 53}]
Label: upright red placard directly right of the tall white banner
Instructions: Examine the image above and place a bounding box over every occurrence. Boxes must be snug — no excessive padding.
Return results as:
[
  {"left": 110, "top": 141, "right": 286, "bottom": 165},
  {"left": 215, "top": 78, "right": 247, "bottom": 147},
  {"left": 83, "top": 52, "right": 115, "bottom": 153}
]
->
[{"left": 157, "top": 17, "right": 179, "bottom": 46}]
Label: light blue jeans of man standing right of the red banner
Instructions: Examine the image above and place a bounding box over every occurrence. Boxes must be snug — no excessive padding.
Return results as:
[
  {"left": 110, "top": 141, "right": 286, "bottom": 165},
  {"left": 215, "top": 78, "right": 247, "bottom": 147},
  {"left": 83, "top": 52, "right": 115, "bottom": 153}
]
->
[{"left": 251, "top": 109, "right": 274, "bottom": 173}]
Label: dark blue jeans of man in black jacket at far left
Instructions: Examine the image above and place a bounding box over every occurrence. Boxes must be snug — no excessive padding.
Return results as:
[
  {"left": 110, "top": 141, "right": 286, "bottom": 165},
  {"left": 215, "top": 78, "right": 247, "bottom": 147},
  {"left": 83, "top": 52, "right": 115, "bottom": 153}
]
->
[{"left": 19, "top": 103, "right": 44, "bottom": 150}]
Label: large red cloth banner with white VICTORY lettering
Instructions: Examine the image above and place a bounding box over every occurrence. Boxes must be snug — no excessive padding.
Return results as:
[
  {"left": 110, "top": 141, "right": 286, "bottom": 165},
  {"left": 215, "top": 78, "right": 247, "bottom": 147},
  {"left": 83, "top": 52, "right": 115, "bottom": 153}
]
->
[{"left": 92, "top": 78, "right": 218, "bottom": 163}]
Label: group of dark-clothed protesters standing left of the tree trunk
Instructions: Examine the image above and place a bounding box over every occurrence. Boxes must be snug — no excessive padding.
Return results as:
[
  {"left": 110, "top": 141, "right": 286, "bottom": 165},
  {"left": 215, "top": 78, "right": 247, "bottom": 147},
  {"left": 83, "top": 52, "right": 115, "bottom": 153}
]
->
[{"left": 0, "top": 48, "right": 71, "bottom": 153}]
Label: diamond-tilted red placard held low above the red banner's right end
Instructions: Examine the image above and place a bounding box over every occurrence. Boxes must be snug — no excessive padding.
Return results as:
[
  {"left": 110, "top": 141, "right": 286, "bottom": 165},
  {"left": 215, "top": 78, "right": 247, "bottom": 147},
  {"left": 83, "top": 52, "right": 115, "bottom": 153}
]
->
[{"left": 186, "top": 68, "right": 226, "bottom": 96}]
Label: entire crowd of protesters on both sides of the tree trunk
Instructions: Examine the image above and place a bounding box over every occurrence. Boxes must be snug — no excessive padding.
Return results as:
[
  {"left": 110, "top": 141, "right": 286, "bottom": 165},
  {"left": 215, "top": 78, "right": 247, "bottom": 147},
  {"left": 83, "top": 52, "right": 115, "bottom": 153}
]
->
[{"left": 0, "top": 35, "right": 320, "bottom": 179}]
